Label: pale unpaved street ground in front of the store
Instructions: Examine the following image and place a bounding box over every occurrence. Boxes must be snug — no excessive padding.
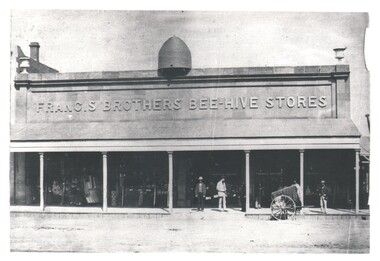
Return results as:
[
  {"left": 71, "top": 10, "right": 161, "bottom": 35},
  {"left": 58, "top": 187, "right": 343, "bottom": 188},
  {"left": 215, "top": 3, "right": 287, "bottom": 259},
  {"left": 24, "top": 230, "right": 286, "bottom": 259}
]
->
[{"left": 10, "top": 209, "right": 370, "bottom": 253}]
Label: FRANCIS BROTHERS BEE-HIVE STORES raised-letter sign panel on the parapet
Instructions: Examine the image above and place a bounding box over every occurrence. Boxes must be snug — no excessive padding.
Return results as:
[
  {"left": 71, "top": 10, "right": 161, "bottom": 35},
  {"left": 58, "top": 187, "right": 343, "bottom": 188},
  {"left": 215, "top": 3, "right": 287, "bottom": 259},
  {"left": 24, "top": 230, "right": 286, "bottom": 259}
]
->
[{"left": 27, "top": 85, "right": 333, "bottom": 122}]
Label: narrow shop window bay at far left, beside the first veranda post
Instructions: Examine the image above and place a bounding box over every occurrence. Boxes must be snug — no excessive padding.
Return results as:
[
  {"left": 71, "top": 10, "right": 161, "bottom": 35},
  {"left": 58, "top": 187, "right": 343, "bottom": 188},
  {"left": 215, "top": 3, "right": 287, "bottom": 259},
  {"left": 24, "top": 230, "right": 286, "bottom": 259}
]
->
[{"left": 10, "top": 152, "right": 40, "bottom": 206}]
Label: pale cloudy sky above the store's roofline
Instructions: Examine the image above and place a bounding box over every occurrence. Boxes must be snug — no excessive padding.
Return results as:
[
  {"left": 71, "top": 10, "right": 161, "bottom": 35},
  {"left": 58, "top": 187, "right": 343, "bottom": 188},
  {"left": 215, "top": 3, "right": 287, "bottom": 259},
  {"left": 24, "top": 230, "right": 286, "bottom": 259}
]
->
[{"left": 11, "top": 10, "right": 368, "bottom": 72}]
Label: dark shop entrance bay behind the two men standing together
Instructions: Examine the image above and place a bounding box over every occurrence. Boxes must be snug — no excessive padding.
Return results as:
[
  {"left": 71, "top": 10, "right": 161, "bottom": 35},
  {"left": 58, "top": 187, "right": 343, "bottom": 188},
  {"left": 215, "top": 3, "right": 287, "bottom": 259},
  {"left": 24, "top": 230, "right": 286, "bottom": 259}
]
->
[{"left": 174, "top": 151, "right": 245, "bottom": 208}]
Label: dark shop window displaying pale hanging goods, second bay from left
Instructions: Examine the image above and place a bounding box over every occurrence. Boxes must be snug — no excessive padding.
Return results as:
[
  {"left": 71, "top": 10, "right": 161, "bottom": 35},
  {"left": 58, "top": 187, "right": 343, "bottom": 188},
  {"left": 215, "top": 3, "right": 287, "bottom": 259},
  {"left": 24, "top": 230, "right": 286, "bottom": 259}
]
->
[{"left": 44, "top": 153, "right": 103, "bottom": 207}]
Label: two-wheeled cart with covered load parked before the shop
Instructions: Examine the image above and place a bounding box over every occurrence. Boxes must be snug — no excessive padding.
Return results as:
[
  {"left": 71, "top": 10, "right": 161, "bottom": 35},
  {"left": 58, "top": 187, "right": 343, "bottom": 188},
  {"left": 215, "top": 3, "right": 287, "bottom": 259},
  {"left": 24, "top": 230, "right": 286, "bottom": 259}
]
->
[{"left": 270, "top": 185, "right": 302, "bottom": 220}]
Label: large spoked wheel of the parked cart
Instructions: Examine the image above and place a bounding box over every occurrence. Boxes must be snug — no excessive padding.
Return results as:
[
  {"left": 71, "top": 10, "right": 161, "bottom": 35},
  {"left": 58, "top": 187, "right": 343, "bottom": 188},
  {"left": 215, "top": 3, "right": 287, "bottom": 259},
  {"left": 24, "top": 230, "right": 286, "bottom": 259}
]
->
[{"left": 270, "top": 195, "right": 296, "bottom": 220}]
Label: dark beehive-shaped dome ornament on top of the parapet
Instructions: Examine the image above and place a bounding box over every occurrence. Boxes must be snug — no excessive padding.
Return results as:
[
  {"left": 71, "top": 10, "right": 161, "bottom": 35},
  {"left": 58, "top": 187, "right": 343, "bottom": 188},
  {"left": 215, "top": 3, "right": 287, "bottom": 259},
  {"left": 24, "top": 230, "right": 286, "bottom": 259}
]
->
[{"left": 158, "top": 36, "right": 191, "bottom": 77}]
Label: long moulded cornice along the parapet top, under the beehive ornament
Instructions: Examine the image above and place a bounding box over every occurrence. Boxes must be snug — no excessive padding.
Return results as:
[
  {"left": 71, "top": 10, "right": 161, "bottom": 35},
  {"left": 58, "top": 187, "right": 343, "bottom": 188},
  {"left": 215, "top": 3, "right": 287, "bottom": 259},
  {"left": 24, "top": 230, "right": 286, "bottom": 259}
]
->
[{"left": 11, "top": 65, "right": 349, "bottom": 89}]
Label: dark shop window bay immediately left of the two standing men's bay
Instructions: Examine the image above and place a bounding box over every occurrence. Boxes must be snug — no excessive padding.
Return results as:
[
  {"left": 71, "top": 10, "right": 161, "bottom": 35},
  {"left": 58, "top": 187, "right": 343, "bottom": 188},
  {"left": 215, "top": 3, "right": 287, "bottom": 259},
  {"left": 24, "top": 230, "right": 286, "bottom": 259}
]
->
[{"left": 107, "top": 152, "right": 168, "bottom": 208}]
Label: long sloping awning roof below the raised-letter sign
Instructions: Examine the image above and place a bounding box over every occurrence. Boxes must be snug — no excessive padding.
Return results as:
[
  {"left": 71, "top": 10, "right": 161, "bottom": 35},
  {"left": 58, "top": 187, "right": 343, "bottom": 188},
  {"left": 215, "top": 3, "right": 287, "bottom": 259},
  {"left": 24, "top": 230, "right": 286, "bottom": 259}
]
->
[{"left": 11, "top": 119, "right": 360, "bottom": 141}]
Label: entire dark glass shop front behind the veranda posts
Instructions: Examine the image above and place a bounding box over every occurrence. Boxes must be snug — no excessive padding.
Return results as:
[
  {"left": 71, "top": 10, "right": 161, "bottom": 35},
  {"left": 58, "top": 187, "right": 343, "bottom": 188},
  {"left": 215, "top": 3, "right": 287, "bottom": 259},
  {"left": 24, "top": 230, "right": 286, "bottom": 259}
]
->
[{"left": 10, "top": 150, "right": 362, "bottom": 209}]
